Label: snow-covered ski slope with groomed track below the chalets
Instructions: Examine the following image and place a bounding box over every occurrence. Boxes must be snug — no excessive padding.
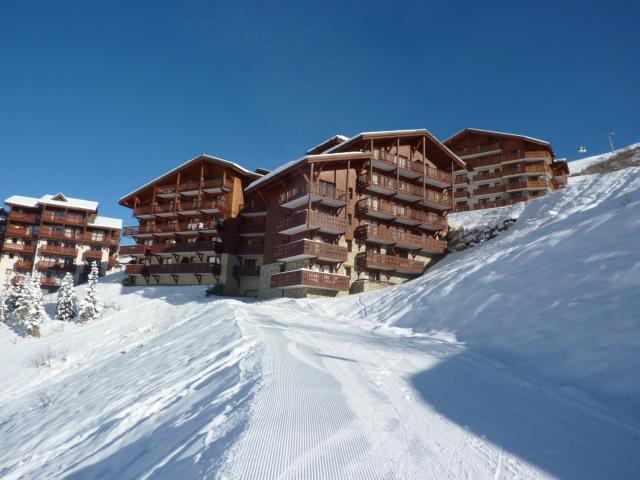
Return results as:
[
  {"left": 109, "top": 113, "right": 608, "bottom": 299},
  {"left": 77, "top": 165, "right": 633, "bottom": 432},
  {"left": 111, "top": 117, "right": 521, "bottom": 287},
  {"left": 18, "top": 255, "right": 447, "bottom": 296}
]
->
[{"left": 0, "top": 169, "right": 640, "bottom": 480}]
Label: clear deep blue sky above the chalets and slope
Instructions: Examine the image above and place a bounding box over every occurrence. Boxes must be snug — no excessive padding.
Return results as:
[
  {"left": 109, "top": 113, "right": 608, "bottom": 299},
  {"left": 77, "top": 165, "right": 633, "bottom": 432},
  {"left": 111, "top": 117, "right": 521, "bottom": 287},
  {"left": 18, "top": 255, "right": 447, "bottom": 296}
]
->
[{"left": 0, "top": 0, "right": 640, "bottom": 224}]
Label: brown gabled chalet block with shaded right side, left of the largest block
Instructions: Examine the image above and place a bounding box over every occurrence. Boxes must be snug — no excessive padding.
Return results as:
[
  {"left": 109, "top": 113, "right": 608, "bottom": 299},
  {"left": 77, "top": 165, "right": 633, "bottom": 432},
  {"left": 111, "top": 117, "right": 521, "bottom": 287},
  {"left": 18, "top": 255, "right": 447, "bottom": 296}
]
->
[{"left": 120, "top": 155, "right": 266, "bottom": 296}]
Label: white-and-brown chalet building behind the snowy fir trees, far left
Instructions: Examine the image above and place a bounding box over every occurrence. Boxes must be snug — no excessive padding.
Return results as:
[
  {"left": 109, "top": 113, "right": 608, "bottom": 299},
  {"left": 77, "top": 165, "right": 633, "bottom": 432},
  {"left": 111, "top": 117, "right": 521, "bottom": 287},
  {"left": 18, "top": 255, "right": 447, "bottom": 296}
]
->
[{"left": 0, "top": 193, "right": 122, "bottom": 290}]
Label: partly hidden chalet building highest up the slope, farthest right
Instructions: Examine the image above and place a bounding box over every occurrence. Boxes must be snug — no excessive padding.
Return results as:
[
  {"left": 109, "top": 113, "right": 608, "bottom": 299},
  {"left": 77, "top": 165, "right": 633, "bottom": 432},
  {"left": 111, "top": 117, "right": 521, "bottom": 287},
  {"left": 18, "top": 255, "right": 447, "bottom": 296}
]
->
[{"left": 444, "top": 128, "right": 569, "bottom": 211}]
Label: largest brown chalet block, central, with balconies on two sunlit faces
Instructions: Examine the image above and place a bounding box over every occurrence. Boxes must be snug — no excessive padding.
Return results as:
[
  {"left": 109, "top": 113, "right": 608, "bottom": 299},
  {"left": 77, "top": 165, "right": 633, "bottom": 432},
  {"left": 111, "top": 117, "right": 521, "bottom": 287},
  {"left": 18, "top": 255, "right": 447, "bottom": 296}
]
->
[{"left": 246, "top": 130, "right": 465, "bottom": 298}]
